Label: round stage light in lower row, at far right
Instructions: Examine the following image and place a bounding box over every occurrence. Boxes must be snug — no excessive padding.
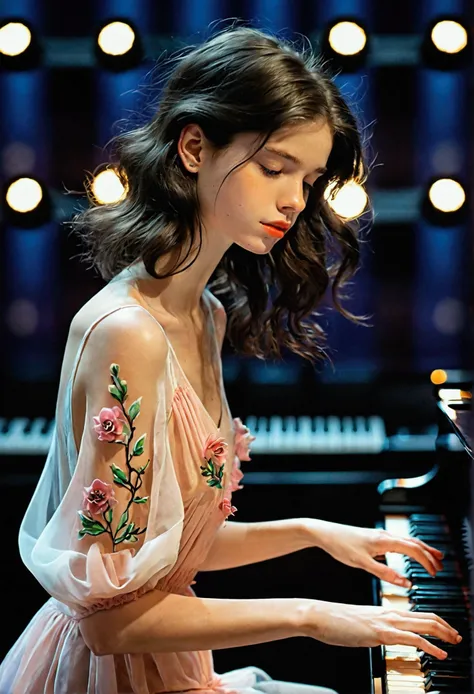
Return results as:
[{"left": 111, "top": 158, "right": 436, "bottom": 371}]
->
[{"left": 422, "top": 178, "right": 467, "bottom": 226}]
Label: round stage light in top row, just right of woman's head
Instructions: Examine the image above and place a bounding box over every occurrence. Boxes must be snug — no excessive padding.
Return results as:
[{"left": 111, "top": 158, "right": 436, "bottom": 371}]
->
[{"left": 321, "top": 17, "right": 369, "bottom": 72}]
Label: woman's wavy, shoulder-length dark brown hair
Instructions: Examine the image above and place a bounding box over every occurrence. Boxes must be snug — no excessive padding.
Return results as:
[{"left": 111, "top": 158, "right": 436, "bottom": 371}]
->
[{"left": 71, "top": 26, "right": 368, "bottom": 362}]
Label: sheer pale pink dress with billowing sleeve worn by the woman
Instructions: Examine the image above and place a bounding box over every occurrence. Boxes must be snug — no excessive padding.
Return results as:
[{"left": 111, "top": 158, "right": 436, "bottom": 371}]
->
[{"left": 0, "top": 290, "right": 336, "bottom": 694}]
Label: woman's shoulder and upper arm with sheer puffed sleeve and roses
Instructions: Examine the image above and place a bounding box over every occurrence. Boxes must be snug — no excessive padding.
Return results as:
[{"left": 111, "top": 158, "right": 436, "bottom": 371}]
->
[{"left": 19, "top": 310, "right": 184, "bottom": 613}]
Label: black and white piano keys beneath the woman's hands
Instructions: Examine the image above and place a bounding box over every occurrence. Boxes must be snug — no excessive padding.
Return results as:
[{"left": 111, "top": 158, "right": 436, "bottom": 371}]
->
[{"left": 381, "top": 514, "right": 472, "bottom": 694}]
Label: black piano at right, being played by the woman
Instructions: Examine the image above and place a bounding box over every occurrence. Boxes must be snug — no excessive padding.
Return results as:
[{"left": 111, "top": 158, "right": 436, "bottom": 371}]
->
[{"left": 371, "top": 388, "right": 474, "bottom": 694}]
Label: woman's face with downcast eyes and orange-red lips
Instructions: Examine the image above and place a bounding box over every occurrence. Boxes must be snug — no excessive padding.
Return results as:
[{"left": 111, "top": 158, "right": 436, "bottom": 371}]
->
[{"left": 183, "top": 121, "right": 333, "bottom": 254}]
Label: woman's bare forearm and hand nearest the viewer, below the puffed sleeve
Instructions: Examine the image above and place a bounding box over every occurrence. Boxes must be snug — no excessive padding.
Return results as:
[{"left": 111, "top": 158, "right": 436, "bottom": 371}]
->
[{"left": 79, "top": 590, "right": 458, "bottom": 659}]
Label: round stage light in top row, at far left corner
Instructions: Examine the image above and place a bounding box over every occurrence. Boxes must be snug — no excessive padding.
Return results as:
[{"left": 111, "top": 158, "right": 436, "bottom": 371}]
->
[{"left": 0, "top": 17, "right": 41, "bottom": 70}]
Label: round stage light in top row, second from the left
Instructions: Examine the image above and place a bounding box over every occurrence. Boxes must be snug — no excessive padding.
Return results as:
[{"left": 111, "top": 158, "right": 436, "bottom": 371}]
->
[{"left": 95, "top": 18, "right": 143, "bottom": 72}]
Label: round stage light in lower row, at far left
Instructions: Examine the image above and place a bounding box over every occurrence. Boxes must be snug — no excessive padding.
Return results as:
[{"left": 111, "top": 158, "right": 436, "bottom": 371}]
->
[{"left": 2, "top": 176, "right": 52, "bottom": 228}]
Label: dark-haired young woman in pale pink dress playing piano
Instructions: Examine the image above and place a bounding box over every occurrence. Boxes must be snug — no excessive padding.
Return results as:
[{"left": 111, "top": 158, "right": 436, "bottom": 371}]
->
[{"left": 0, "top": 27, "right": 458, "bottom": 694}]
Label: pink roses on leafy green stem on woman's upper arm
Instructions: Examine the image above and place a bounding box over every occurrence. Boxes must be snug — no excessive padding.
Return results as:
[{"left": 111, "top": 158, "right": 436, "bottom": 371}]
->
[{"left": 78, "top": 364, "right": 150, "bottom": 552}]
